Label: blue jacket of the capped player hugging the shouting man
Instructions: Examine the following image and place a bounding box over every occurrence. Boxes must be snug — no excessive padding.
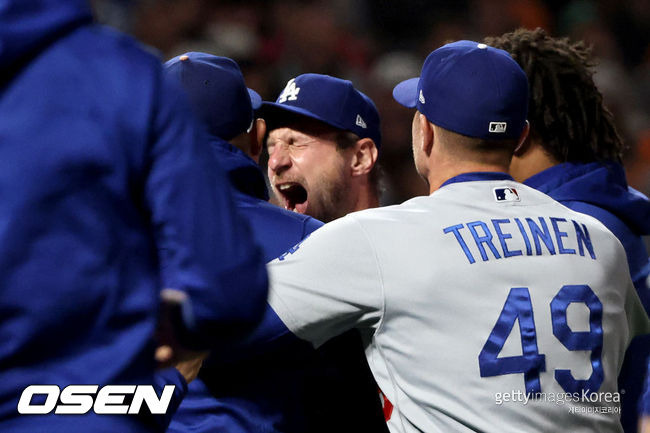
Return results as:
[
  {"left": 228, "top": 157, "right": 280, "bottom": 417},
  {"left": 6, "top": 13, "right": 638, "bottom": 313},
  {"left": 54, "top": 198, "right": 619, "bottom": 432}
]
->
[{"left": 168, "top": 141, "right": 322, "bottom": 433}]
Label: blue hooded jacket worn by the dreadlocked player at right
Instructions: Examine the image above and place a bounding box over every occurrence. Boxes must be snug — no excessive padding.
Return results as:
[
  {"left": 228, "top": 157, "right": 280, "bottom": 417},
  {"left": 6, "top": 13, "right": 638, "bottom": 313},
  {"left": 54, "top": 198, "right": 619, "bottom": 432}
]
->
[{"left": 524, "top": 162, "right": 650, "bottom": 433}]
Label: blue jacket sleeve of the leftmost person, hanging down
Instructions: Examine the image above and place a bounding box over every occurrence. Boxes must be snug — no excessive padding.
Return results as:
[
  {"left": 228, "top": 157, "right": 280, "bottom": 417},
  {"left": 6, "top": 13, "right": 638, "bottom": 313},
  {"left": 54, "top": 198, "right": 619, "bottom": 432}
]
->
[{"left": 145, "top": 74, "right": 267, "bottom": 349}]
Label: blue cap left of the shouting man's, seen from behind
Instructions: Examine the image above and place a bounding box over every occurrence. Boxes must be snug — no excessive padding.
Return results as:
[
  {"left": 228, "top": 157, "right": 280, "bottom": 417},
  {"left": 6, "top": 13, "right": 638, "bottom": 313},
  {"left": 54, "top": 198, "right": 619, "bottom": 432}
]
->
[{"left": 164, "top": 52, "right": 262, "bottom": 140}]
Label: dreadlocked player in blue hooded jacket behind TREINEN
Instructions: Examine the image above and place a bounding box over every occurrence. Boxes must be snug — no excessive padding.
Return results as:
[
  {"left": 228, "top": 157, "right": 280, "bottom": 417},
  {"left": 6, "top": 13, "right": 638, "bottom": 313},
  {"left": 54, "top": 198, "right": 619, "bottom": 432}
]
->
[{"left": 486, "top": 29, "right": 650, "bottom": 432}]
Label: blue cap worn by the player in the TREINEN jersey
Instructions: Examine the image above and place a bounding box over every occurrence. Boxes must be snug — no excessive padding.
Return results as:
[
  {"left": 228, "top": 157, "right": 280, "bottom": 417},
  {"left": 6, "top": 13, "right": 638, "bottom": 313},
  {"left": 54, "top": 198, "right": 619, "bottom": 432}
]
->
[{"left": 393, "top": 41, "right": 528, "bottom": 140}]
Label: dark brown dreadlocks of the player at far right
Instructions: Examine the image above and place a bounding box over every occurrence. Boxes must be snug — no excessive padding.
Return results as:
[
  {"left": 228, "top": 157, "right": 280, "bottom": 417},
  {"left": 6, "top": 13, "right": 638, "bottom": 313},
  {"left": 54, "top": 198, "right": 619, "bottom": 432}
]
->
[{"left": 484, "top": 28, "right": 625, "bottom": 162}]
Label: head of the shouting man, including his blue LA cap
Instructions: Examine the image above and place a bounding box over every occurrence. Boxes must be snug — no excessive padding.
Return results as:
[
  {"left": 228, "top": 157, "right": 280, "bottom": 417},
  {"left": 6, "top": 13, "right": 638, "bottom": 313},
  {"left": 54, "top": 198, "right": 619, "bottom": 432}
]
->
[{"left": 261, "top": 74, "right": 381, "bottom": 222}]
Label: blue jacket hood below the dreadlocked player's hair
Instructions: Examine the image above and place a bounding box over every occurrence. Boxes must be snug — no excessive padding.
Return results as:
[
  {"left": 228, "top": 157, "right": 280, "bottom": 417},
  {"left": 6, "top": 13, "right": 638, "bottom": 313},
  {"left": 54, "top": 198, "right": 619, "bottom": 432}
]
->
[{"left": 524, "top": 162, "right": 650, "bottom": 235}]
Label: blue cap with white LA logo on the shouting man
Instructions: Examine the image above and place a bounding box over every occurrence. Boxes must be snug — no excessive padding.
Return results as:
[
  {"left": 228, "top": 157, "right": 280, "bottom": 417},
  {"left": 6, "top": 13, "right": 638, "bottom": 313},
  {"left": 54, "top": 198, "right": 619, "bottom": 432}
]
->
[{"left": 262, "top": 74, "right": 381, "bottom": 148}]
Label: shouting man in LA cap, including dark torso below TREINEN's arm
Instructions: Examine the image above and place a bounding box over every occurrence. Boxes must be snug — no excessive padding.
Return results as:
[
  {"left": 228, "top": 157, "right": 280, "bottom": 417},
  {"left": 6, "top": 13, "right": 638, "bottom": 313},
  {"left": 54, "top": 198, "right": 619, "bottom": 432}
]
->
[{"left": 261, "top": 74, "right": 386, "bottom": 433}]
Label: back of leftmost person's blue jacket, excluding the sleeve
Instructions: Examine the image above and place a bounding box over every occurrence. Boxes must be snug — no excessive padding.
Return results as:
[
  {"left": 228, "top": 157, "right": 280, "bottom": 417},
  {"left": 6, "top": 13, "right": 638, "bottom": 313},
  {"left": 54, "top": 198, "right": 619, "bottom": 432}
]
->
[{"left": 0, "top": 0, "right": 208, "bottom": 431}]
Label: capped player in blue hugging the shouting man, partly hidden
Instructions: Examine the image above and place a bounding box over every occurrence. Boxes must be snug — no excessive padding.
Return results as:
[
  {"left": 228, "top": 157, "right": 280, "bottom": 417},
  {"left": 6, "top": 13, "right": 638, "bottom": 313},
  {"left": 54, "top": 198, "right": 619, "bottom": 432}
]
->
[{"left": 159, "top": 52, "right": 323, "bottom": 433}]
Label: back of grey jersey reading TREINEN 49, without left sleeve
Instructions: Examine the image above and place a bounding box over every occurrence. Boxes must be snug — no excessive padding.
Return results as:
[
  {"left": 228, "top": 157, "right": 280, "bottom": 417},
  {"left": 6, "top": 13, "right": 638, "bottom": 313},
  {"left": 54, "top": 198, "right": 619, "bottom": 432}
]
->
[{"left": 352, "top": 176, "right": 647, "bottom": 432}]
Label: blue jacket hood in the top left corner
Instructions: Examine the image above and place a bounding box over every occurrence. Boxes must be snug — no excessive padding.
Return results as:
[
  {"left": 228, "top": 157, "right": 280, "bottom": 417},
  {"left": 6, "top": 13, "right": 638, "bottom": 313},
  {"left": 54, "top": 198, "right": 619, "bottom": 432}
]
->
[{"left": 0, "top": 0, "right": 92, "bottom": 70}]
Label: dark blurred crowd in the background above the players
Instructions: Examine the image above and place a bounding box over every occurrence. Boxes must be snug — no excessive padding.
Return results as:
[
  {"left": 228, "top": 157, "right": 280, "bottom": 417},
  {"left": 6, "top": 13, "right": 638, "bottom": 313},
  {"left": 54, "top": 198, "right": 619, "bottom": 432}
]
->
[{"left": 93, "top": 0, "right": 650, "bottom": 205}]
